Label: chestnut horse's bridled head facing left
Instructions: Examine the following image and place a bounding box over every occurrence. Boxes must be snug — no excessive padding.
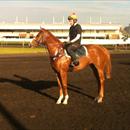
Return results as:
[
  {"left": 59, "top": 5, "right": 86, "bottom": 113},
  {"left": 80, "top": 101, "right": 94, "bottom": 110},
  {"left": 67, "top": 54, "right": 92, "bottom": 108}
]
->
[{"left": 29, "top": 28, "right": 46, "bottom": 48}]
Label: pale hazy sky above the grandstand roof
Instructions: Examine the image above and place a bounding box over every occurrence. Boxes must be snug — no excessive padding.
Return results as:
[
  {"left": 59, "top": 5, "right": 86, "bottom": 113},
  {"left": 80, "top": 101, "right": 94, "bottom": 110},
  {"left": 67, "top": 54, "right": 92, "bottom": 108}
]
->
[{"left": 0, "top": 0, "right": 130, "bottom": 26}]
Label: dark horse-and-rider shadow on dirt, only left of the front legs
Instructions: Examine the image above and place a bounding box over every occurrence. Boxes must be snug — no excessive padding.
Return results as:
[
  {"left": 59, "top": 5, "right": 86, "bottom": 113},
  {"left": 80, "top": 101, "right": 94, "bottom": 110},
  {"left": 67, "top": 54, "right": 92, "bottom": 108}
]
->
[{"left": 0, "top": 75, "right": 57, "bottom": 101}]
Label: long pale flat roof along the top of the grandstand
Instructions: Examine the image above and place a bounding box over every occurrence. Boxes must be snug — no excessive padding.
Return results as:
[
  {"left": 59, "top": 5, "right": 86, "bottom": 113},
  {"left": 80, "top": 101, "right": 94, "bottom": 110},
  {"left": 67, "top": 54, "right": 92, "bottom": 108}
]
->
[{"left": 0, "top": 23, "right": 121, "bottom": 30}]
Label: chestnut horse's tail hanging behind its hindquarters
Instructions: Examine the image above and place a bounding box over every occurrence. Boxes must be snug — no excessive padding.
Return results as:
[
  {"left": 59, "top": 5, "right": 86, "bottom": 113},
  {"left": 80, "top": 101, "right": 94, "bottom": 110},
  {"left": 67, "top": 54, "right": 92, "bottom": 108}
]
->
[{"left": 106, "top": 53, "right": 112, "bottom": 79}]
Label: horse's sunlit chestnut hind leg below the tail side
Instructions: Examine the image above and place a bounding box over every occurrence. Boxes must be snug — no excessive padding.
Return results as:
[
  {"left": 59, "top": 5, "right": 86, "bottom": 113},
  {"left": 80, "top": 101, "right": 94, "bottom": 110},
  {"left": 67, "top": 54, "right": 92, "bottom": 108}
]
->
[{"left": 95, "top": 69, "right": 104, "bottom": 103}]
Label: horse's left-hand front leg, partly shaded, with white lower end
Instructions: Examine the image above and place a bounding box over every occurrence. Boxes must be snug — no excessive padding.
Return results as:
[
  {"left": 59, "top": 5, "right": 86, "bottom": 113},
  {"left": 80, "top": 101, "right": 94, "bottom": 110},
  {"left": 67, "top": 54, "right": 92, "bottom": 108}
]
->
[{"left": 56, "top": 73, "right": 64, "bottom": 104}]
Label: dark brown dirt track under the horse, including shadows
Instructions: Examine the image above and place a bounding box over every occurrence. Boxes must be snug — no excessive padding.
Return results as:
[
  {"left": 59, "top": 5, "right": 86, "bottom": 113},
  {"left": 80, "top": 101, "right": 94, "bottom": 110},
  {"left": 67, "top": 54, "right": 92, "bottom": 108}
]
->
[{"left": 0, "top": 54, "right": 130, "bottom": 130}]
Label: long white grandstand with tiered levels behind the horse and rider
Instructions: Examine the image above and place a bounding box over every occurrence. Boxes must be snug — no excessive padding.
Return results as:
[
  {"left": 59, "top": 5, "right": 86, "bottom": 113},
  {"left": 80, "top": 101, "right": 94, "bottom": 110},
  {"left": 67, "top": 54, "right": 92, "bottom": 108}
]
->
[{"left": 0, "top": 23, "right": 129, "bottom": 46}]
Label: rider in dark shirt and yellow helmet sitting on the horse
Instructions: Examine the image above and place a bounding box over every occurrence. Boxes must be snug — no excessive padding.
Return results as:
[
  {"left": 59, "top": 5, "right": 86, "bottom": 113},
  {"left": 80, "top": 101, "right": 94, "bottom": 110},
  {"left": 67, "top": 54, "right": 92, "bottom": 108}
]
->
[{"left": 64, "top": 13, "right": 82, "bottom": 67}]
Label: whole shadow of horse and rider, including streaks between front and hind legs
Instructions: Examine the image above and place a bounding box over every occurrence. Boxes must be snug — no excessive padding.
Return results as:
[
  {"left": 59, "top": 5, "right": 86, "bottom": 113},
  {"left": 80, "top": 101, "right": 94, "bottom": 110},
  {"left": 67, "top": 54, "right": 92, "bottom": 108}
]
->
[{"left": 0, "top": 75, "right": 94, "bottom": 101}]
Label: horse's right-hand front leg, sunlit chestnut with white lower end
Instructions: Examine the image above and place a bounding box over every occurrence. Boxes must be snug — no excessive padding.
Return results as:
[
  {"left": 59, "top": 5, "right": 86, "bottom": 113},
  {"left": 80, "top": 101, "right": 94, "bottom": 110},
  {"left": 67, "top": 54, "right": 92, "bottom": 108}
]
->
[{"left": 60, "top": 71, "right": 69, "bottom": 105}]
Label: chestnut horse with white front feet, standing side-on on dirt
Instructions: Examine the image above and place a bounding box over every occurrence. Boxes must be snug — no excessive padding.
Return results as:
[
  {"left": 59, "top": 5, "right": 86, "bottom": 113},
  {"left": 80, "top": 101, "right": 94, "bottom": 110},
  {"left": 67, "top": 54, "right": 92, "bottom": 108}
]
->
[{"left": 30, "top": 28, "right": 111, "bottom": 104}]
